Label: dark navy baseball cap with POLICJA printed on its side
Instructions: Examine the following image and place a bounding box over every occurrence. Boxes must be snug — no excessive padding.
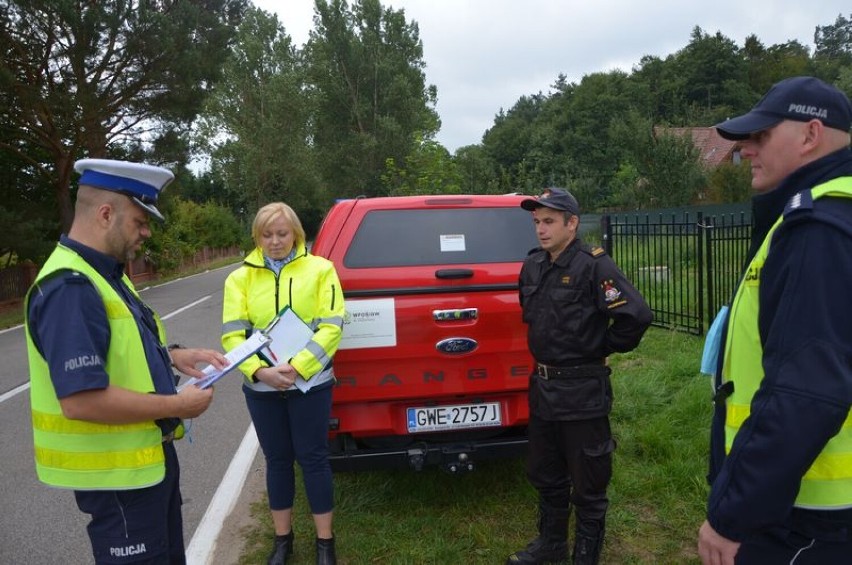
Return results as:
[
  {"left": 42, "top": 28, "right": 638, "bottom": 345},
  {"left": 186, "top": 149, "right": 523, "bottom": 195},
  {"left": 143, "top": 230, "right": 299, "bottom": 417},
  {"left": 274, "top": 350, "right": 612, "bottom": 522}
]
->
[{"left": 714, "top": 77, "right": 852, "bottom": 141}]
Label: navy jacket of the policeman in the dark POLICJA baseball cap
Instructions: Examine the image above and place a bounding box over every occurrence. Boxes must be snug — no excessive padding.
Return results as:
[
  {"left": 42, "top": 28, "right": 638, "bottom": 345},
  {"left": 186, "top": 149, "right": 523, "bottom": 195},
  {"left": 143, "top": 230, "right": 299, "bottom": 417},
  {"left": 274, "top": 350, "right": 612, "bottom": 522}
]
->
[{"left": 707, "top": 148, "right": 852, "bottom": 563}]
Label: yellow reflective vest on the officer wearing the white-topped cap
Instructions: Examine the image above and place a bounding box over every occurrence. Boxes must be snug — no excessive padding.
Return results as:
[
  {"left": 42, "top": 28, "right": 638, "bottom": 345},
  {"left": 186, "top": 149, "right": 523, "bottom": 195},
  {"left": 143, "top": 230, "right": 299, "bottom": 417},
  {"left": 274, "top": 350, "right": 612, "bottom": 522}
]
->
[{"left": 24, "top": 245, "right": 165, "bottom": 490}]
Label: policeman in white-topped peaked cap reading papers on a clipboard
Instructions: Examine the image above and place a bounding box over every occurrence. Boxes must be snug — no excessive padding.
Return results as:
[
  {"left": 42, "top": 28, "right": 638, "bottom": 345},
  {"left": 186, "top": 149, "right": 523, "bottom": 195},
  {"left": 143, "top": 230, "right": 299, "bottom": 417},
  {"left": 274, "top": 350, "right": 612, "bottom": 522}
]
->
[{"left": 25, "top": 159, "right": 227, "bottom": 564}]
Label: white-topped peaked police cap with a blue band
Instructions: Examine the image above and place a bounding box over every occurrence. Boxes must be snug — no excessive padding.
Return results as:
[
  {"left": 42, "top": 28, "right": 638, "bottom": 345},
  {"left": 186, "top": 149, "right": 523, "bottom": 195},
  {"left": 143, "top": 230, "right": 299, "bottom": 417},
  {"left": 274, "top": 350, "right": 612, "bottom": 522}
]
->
[{"left": 74, "top": 159, "right": 175, "bottom": 221}]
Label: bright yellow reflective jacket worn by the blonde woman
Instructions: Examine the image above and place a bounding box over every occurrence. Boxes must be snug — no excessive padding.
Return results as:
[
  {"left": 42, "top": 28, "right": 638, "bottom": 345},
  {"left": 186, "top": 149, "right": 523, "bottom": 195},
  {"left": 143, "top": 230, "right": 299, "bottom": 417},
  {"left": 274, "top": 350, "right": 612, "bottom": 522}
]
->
[{"left": 222, "top": 244, "right": 344, "bottom": 390}]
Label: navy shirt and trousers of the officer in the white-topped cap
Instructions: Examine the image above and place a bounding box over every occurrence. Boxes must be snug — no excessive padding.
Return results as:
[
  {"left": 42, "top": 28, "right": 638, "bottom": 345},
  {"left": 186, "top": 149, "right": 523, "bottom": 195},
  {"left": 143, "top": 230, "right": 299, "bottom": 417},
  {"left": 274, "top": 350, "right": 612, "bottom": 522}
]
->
[{"left": 29, "top": 236, "right": 185, "bottom": 564}]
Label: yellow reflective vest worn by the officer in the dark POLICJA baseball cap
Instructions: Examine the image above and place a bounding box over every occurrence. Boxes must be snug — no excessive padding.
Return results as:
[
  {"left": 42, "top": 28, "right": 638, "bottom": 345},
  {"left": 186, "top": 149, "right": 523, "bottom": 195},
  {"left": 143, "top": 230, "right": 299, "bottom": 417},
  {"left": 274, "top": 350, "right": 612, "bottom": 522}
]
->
[{"left": 722, "top": 177, "right": 852, "bottom": 509}]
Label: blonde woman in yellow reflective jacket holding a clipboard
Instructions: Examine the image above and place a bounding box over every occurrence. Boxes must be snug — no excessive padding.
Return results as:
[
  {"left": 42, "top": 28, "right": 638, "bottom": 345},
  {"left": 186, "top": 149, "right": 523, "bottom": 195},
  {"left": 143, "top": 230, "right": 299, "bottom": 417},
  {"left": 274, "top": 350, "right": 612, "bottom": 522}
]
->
[{"left": 222, "top": 202, "right": 344, "bottom": 565}]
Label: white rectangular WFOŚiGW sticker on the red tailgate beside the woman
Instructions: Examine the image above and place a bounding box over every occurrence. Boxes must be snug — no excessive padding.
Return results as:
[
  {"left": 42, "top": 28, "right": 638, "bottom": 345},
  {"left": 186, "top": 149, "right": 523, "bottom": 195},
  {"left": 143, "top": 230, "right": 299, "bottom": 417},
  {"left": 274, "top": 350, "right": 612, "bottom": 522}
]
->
[{"left": 338, "top": 298, "right": 396, "bottom": 349}]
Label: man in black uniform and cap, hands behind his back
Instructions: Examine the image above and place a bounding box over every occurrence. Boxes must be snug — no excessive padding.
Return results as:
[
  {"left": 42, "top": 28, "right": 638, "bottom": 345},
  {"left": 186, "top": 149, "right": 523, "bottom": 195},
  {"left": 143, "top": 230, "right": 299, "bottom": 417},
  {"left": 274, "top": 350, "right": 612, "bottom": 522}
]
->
[{"left": 507, "top": 188, "right": 652, "bottom": 565}]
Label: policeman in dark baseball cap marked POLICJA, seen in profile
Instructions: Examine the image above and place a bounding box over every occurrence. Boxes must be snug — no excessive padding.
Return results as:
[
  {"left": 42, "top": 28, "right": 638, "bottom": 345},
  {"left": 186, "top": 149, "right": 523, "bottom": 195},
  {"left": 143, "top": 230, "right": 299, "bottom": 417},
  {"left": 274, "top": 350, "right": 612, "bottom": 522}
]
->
[{"left": 698, "top": 76, "right": 852, "bottom": 565}]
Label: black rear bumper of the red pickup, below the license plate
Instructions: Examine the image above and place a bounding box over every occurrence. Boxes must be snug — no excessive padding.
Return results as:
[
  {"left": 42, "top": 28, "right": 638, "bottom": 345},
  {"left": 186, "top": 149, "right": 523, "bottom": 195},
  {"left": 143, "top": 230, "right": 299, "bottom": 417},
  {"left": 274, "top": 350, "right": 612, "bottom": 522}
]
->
[{"left": 330, "top": 428, "right": 528, "bottom": 473}]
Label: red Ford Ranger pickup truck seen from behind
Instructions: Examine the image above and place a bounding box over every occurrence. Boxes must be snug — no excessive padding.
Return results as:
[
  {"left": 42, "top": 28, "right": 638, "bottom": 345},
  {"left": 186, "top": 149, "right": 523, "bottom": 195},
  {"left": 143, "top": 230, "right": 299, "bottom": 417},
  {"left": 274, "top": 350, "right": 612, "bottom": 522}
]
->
[{"left": 311, "top": 195, "right": 538, "bottom": 472}]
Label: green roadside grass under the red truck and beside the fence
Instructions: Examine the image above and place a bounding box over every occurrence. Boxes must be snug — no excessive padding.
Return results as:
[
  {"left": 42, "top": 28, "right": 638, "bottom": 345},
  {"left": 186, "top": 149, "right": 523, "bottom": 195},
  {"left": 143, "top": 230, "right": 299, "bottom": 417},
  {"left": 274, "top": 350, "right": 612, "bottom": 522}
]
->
[{"left": 240, "top": 328, "right": 711, "bottom": 565}]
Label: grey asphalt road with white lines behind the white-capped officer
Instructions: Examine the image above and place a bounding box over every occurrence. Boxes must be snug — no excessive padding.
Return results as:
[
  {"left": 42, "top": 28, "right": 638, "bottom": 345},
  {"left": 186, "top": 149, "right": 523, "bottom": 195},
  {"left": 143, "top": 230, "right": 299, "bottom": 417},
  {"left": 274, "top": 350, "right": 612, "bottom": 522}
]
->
[{"left": 0, "top": 265, "right": 250, "bottom": 564}]
